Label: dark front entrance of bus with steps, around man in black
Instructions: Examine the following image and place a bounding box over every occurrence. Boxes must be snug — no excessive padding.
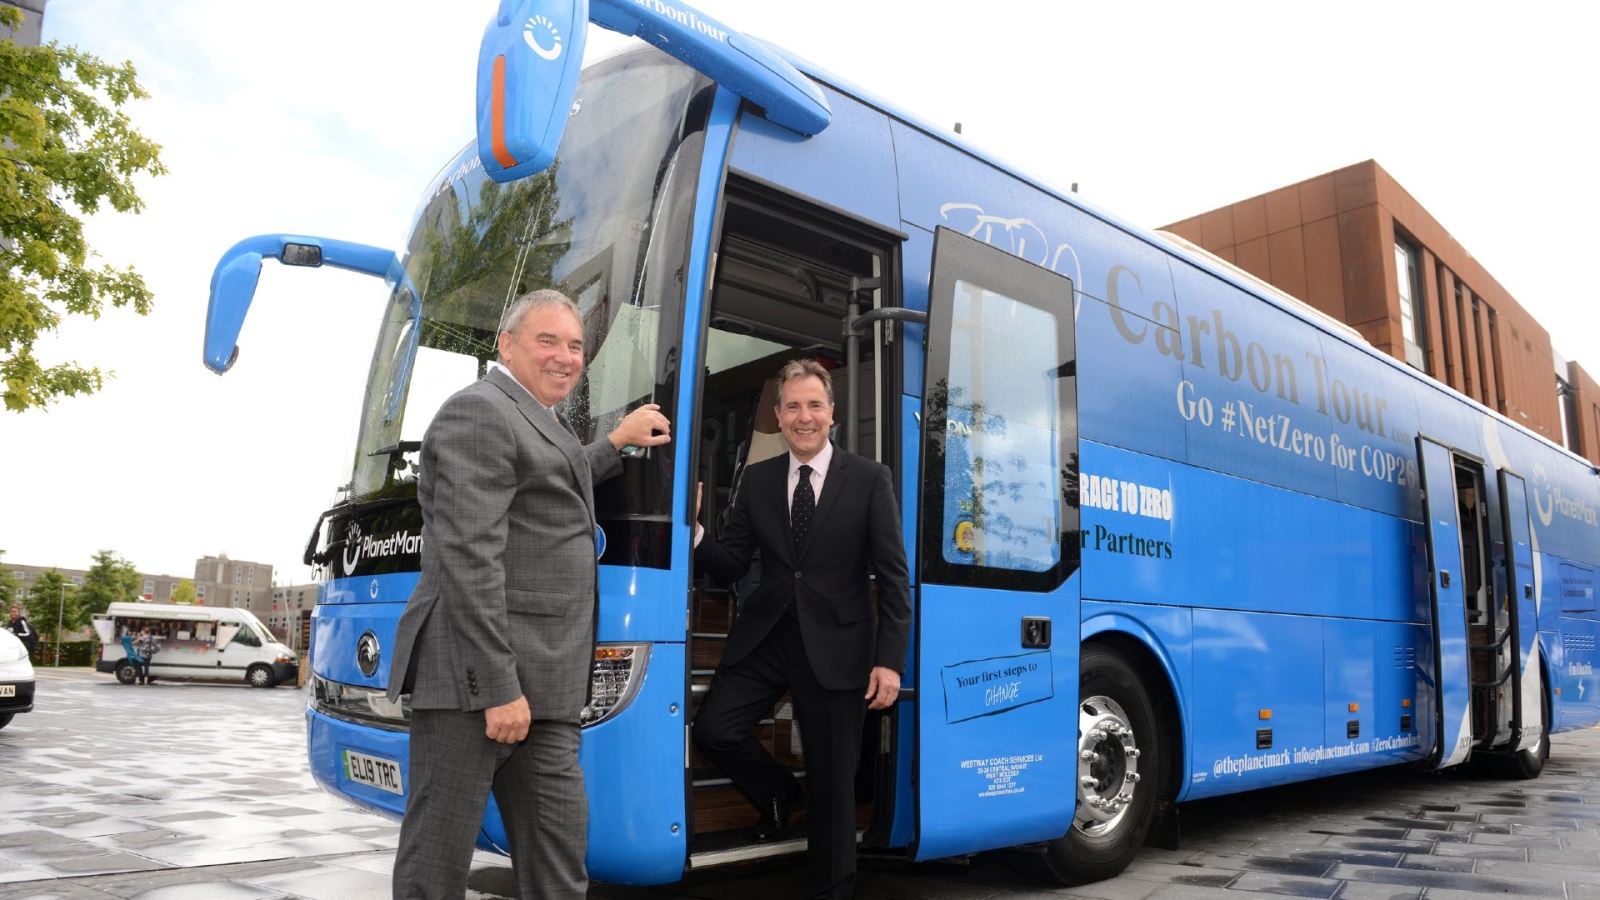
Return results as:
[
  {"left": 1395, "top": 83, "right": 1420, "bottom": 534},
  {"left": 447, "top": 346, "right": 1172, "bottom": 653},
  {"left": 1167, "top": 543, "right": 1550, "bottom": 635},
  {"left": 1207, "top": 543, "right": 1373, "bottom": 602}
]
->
[{"left": 686, "top": 178, "right": 894, "bottom": 868}]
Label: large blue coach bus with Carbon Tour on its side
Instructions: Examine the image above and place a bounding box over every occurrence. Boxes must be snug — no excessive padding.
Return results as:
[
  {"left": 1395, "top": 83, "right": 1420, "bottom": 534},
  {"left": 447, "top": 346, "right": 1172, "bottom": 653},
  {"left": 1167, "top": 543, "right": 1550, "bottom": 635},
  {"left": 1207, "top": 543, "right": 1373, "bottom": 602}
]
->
[{"left": 206, "top": 0, "right": 1600, "bottom": 884}]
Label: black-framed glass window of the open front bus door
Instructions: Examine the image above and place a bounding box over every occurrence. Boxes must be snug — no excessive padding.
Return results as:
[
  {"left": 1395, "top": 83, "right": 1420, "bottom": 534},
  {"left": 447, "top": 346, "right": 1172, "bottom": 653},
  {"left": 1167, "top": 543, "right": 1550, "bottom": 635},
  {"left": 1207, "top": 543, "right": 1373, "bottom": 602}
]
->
[{"left": 923, "top": 229, "right": 1078, "bottom": 591}]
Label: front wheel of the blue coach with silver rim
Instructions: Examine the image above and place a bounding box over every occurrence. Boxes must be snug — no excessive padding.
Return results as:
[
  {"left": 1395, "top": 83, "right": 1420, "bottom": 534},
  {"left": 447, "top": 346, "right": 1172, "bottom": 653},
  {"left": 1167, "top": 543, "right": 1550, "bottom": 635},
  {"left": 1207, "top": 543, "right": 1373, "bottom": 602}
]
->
[{"left": 1029, "top": 644, "right": 1168, "bottom": 884}]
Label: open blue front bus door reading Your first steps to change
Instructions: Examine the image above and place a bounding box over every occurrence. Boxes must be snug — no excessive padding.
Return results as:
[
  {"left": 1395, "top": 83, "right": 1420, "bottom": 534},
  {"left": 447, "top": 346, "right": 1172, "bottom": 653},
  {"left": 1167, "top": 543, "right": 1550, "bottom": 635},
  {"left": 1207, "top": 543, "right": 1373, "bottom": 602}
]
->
[{"left": 915, "top": 227, "right": 1078, "bottom": 860}]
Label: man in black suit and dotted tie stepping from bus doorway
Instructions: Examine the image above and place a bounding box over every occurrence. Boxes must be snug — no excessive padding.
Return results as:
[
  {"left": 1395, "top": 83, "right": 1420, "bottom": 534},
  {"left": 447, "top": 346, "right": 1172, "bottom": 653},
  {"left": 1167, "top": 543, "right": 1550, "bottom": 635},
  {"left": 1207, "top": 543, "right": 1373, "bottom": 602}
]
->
[{"left": 694, "top": 359, "right": 910, "bottom": 897}]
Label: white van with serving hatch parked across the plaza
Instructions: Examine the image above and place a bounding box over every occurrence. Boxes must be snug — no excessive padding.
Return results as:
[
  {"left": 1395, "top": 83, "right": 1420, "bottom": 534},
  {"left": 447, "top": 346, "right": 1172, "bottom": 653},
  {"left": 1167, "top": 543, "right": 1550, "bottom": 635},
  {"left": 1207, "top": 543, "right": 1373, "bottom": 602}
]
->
[{"left": 94, "top": 604, "right": 299, "bottom": 687}]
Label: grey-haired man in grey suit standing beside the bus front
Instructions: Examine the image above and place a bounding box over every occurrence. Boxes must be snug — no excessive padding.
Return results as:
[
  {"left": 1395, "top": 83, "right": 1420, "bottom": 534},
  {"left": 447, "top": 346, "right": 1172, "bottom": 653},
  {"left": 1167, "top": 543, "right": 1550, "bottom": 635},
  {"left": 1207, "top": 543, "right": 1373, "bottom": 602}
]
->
[{"left": 389, "top": 290, "right": 670, "bottom": 900}]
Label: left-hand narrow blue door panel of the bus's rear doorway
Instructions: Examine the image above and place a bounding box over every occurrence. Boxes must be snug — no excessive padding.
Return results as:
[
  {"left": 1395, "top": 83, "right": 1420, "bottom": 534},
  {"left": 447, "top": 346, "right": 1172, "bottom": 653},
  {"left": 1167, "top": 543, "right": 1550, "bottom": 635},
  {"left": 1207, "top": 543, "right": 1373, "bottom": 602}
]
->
[{"left": 1416, "top": 437, "right": 1472, "bottom": 769}]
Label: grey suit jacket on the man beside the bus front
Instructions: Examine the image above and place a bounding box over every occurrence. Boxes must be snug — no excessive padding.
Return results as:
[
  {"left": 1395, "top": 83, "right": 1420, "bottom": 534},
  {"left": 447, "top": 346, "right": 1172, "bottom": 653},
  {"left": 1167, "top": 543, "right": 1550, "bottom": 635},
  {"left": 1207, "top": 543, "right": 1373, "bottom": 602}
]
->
[{"left": 389, "top": 368, "right": 622, "bottom": 721}]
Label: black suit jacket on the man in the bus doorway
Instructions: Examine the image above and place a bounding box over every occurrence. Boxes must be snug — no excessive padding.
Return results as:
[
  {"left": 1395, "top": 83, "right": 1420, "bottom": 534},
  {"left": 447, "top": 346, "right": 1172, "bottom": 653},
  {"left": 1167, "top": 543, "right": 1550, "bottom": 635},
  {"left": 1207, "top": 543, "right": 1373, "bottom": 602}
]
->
[{"left": 694, "top": 447, "right": 910, "bottom": 690}]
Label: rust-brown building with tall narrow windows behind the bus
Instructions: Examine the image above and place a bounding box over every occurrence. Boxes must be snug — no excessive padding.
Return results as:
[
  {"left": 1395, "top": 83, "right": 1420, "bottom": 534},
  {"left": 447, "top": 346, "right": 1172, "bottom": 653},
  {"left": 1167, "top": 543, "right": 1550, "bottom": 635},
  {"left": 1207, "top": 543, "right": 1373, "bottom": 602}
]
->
[{"left": 1165, "top": 160, "right": 1600, "bottom": 463}]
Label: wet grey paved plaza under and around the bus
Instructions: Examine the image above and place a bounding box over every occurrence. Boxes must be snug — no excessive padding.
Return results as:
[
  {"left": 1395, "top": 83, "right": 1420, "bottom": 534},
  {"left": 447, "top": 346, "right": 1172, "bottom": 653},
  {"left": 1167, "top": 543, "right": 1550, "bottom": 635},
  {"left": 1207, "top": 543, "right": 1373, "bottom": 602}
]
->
[{"left": 0, "top": 669, "right": 1600, "bottom": 900}]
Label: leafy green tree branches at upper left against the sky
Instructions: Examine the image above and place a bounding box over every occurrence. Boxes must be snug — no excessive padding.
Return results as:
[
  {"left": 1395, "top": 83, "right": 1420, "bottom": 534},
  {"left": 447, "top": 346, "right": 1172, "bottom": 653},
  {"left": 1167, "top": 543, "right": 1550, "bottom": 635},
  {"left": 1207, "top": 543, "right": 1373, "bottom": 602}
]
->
[{"left": 0, "top": 6, "right": 166, "bottom": 412}]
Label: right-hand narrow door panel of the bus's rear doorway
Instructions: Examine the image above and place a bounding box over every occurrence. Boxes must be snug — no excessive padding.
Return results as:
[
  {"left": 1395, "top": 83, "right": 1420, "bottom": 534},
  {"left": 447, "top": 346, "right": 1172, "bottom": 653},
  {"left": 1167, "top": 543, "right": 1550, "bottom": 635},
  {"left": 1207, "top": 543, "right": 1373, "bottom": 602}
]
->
[{"left": 1499, "top": 469, "right": 1546, "bottom": 749}]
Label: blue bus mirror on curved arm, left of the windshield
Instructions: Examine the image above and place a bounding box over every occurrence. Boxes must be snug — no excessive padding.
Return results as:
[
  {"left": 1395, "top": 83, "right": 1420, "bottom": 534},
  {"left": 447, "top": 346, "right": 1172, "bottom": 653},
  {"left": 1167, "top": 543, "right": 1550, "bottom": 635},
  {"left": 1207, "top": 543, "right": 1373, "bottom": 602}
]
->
[{"left": 202, "top": 234, "right": 421, "bottom": 375}]
